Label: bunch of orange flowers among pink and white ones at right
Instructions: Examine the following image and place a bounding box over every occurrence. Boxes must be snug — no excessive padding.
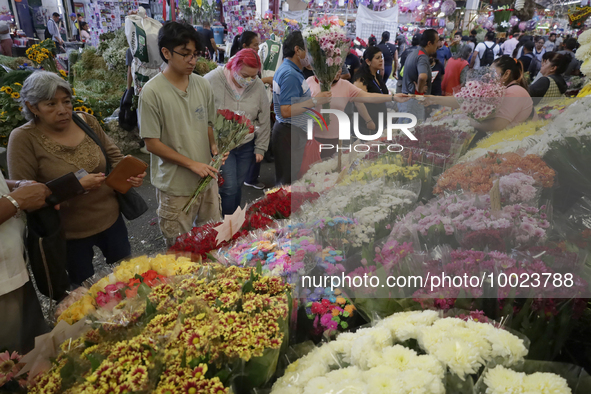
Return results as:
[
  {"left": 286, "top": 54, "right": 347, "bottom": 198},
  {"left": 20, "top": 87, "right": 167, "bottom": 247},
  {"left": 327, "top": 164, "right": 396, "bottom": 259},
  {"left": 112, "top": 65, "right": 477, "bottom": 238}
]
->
[{"left": 433, "top": 152, "right": 555, "bottom": 194}]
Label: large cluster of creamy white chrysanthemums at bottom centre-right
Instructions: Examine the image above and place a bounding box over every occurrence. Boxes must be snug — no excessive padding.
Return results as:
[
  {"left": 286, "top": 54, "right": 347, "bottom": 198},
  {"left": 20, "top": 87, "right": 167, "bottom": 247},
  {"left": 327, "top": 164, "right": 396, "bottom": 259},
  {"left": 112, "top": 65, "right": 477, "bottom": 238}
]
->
[{"left": 272, "top": 311, "right": 527, "bottom": 394}]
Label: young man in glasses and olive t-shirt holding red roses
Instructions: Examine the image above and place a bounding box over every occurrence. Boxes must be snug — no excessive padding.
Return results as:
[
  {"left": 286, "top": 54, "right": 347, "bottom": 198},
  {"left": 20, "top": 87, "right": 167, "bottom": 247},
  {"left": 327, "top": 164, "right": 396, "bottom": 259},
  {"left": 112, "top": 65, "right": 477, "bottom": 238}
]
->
[{"left": 139, "top": 22, "right": 225, "bottom": 246}]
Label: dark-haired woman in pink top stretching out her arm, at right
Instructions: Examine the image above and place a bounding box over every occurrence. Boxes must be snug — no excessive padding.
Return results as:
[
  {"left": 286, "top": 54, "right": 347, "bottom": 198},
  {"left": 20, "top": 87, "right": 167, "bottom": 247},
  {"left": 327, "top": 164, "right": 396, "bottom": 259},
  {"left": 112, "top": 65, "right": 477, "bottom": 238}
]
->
[{"left": 423, "top": 55, "right": 533, "bottom": 132}]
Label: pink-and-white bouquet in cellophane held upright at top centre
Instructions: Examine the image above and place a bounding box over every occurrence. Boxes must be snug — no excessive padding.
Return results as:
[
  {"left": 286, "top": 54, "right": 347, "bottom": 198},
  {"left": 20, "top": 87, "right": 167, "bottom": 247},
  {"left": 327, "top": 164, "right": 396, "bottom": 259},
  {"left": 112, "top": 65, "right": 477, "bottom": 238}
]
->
[{"left": 303, "top": 16, "right": 350, "bottom": 124}]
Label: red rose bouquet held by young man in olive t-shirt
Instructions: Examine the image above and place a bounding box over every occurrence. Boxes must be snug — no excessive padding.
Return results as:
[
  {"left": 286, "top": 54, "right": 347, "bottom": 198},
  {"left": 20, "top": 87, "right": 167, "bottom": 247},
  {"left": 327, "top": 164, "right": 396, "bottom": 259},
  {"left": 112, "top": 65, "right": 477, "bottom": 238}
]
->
[{"left": 183, "top": 109, "right": 254, "bottom": 213}]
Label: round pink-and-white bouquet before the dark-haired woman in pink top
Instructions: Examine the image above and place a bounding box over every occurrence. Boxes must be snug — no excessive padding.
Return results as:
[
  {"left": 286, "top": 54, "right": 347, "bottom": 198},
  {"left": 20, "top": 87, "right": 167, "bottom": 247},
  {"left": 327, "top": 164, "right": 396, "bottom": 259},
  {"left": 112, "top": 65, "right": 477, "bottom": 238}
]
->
[{"left": 454, "top": 69, "right": 505, "bottom": 121}]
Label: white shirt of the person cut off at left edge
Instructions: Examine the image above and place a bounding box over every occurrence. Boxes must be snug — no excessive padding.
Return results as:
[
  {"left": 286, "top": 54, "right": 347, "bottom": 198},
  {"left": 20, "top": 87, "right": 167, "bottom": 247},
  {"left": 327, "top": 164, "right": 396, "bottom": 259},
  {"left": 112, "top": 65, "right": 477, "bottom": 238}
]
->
[{"left": 0, "top": 172, "right": 29, "bottom": 296}]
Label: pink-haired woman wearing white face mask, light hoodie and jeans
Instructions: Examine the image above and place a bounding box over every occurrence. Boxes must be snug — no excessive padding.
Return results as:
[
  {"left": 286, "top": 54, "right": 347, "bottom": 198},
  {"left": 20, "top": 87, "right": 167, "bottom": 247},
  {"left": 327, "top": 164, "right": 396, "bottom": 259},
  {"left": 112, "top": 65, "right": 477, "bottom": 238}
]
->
[{"left": 205, "top": 48, "right": 271, "bottom": 215}]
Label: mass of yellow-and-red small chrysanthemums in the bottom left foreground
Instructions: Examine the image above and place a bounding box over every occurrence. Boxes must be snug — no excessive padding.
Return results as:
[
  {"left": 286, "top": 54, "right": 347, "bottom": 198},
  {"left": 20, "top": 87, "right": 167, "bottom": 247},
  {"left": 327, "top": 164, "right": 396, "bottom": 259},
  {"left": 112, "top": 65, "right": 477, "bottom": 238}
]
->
[{"left": 29, "top": 265, "right": 290, "bottom": 394}]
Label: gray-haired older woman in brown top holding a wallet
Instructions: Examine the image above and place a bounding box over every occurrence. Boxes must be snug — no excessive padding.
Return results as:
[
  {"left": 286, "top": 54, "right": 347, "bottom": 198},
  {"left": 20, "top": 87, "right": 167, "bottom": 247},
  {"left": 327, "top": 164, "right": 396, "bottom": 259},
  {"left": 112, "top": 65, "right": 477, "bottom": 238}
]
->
[{"left": 8, "top": 71, "right": 146, "bottom": 284}]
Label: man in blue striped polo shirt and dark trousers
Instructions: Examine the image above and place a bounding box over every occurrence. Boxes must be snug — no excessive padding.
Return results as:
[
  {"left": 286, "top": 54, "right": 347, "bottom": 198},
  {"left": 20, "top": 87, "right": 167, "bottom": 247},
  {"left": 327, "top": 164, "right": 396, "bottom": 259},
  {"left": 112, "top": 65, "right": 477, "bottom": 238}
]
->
[{"left": 271, "top": 31, "right": 331, "bottom": 185}]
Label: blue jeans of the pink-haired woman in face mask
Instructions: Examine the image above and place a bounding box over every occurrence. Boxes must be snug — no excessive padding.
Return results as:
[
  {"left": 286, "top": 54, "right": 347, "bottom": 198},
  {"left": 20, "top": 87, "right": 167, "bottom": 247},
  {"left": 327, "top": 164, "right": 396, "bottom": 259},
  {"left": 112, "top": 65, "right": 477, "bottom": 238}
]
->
[{"left": 220, "top": 141, "right": 255, "bottom": 215}]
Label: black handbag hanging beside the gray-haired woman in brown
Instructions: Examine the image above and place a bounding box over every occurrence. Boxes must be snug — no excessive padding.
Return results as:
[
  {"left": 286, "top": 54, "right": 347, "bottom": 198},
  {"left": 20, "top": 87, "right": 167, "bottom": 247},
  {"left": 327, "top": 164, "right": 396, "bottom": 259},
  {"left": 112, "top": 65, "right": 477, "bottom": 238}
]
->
[{"left": 26, "top": 206, "right": 70, "bottom": 301}]
